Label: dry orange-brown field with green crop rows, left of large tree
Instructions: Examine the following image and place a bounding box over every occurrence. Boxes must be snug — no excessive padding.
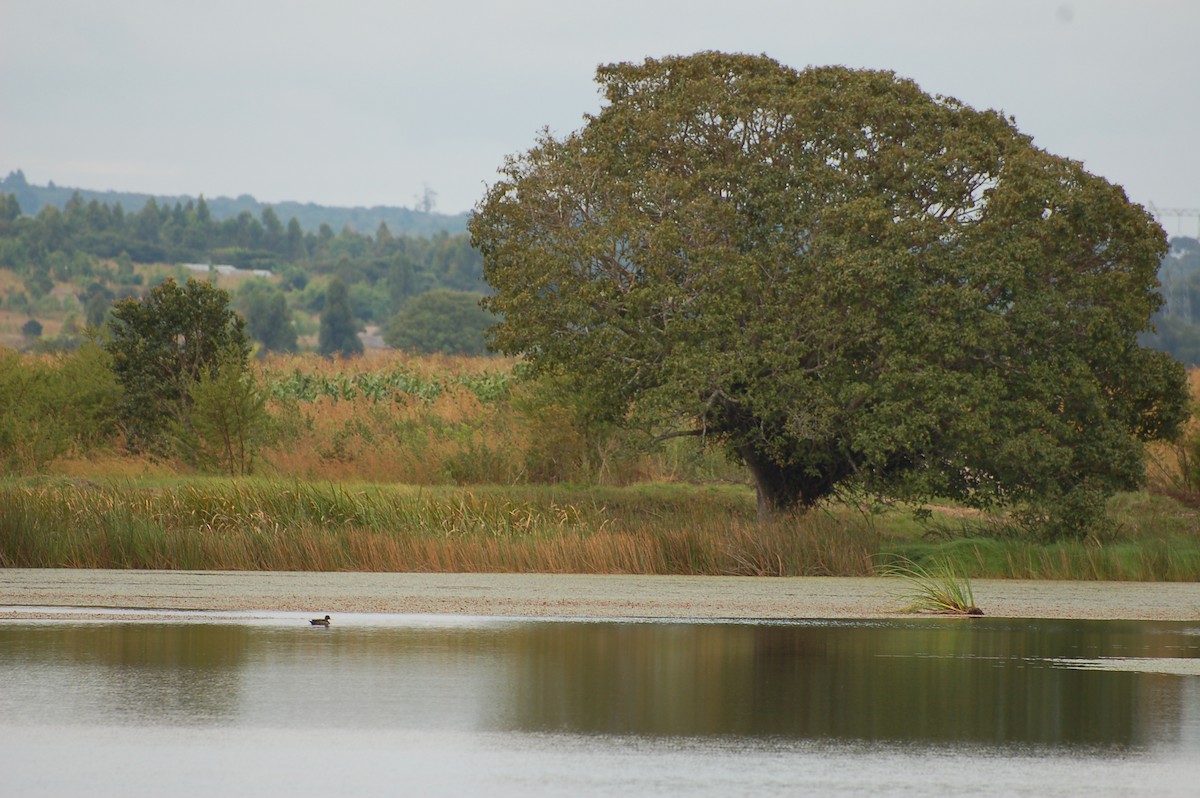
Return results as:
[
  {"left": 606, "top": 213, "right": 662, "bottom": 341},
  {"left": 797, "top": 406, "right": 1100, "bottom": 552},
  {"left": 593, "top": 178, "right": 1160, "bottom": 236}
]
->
[{"left": 224, "top": 353, "right": 745, "bottom": 486}]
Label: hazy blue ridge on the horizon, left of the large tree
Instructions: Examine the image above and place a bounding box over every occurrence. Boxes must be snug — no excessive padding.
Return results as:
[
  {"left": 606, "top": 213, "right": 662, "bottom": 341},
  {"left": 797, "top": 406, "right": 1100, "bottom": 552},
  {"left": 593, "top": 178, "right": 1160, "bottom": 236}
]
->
[{"left": 0, "top": 169, "right": 469, "bottom": 236}]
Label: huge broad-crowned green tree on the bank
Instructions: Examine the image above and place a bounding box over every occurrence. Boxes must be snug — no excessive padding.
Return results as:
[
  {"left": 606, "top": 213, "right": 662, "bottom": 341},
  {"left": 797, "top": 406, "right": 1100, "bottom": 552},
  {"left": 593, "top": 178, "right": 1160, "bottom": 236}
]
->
[{"left": 470, "top": 53, "right": 1186, "bottom": 532}]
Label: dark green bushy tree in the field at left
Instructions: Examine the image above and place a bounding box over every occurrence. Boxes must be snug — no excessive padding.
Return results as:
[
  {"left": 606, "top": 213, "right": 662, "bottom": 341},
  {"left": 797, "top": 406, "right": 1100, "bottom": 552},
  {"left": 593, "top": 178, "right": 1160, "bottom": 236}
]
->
[{"left": 104, "top": 280, "right": 250, "bottom": 451}]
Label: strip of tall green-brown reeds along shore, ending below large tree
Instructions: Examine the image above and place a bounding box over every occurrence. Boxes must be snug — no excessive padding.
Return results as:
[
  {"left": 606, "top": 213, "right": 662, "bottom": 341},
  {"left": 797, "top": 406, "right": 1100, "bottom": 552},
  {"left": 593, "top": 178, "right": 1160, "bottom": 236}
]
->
[{"left": 0, "top": 481, "right": 876, "bottom": 575}]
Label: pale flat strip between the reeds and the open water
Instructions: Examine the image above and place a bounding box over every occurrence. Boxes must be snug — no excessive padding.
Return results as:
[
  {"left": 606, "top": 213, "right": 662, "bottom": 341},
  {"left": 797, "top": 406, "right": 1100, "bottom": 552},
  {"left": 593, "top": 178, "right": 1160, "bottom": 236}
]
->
[{"left": 0, "top": 569, "right": 1200, "bottom": 620}]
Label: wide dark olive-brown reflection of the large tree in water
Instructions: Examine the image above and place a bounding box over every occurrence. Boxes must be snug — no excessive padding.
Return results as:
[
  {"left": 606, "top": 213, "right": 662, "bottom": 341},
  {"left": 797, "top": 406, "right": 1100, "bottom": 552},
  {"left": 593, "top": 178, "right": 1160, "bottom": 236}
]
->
[{"left": 503, "top": 620, "right": 1182, "bottom": 746}]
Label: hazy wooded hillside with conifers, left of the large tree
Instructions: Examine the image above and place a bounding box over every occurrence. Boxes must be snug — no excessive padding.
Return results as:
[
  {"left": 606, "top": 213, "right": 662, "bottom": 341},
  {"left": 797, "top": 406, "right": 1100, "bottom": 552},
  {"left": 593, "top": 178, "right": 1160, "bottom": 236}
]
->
[{"left": 0, "top": 182, "right": 487, "bottom": 353}]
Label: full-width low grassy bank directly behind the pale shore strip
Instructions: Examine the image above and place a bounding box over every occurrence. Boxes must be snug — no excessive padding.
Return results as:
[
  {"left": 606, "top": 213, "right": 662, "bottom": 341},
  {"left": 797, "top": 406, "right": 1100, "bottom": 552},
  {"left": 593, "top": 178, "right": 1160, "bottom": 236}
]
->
[{"left": 0, "top": 478, "right": 1200, "bottom": 581}]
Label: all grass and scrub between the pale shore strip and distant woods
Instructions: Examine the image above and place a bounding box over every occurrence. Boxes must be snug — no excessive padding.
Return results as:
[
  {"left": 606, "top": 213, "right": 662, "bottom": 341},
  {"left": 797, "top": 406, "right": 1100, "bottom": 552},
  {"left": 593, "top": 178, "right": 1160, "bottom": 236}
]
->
[{"left": 0, "top": 348, "right": 1200, "bottom": 581}]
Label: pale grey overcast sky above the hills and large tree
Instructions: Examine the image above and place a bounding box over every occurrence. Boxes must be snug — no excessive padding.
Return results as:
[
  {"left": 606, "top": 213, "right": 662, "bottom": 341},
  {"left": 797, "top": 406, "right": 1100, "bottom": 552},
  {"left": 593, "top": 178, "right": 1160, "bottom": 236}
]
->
[{"left": 0, "top": 0, "right": 1200, "bottom": 235}]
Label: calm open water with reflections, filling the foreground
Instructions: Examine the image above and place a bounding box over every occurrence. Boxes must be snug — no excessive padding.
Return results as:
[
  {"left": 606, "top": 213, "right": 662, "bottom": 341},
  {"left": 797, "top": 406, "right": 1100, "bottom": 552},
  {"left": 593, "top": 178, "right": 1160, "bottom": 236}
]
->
[{"left": 0, "top": 614, "right": 1200, "bottom": 797}]
